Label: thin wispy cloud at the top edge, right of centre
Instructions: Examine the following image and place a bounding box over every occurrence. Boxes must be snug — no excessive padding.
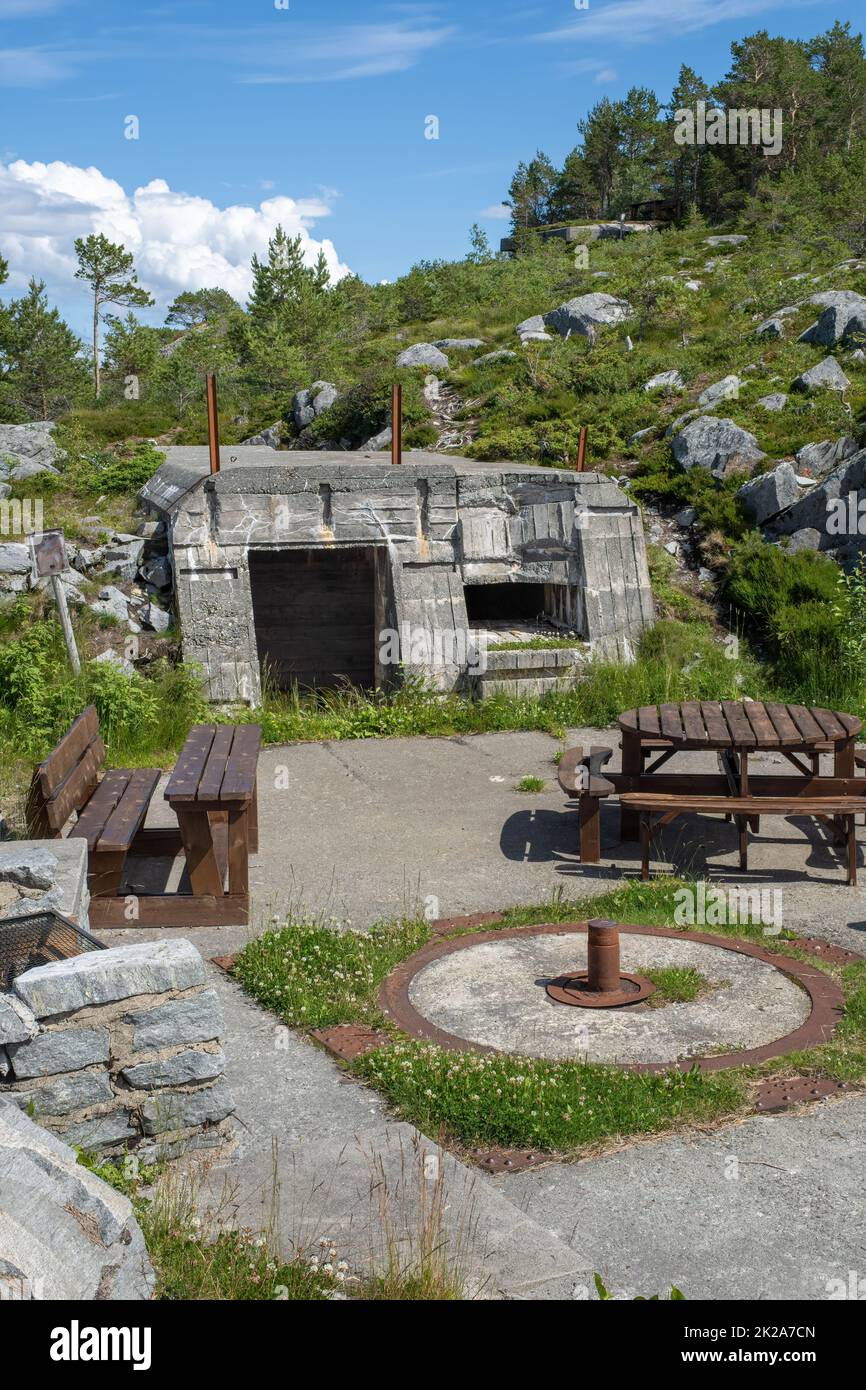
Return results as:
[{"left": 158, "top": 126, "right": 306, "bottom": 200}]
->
[{"left": 537, "top": 0, "right": 815, "bottom": 43}]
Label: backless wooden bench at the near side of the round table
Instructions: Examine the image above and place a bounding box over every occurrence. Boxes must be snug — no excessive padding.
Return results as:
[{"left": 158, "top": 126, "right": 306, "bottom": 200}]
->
[{"left": 620, "top": 792, "right": 866, "bottom": 887}]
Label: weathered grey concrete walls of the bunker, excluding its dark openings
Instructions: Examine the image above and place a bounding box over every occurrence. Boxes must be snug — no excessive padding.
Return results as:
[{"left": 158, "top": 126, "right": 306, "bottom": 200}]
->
[{"left": 142, "top": 448, "right": 653, "bottom": 703}]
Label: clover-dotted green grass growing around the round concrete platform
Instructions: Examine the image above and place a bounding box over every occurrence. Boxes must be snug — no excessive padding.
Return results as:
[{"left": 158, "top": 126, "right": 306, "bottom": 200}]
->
[{"left": 235, "top": 878, "right": 866, "bottom": 1154}]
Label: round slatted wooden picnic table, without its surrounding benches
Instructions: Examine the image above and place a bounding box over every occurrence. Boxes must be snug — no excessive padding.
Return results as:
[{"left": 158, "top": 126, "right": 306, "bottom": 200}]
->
[{"left": 619, "top": 701, "right": 862, "bottom": 840}]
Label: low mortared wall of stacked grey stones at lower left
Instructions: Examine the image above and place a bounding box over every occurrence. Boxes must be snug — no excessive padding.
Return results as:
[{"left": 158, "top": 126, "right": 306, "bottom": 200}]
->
[{"left": 0, "top": 938, "right": 234, "bottom": 1161}]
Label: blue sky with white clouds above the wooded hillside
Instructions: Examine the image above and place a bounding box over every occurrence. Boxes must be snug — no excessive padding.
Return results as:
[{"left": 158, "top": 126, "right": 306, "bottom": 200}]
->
[{"left": 0, "top": 0, "right": 863, "bottom": 329}]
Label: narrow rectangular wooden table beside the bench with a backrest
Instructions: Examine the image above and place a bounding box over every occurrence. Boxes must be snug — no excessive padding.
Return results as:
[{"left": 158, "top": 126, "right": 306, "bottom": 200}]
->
[{"left": 164, "top": 724, "right": 261, "bottom": 924}]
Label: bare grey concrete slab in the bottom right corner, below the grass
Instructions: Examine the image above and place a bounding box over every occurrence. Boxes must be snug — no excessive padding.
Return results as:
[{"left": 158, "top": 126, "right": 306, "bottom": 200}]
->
[{"left": 489, "top": 1095, "right": 866, "bottom": 1300}]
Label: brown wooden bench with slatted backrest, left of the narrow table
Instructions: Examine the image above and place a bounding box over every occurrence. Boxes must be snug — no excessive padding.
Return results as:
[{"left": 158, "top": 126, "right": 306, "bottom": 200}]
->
[{"left": 26, "top": 705, "right": 160, "bottom": 898}]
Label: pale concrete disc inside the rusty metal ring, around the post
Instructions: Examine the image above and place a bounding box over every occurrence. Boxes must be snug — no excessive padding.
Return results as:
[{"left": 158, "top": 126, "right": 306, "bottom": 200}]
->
[{"left": 409, "top": 931, "right": 810, "bottom": 1062}]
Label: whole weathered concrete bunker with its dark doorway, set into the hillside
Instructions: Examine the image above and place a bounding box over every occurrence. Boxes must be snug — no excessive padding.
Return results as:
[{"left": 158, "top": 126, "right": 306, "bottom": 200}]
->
[{"left": 142, "top": 446, "right": 653, "bottom": 705}]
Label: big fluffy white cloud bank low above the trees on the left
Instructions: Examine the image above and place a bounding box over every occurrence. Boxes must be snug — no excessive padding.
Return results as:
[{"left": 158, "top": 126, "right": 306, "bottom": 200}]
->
[{"left": 0, "top": 160, "right": 348, "bottom": 307}]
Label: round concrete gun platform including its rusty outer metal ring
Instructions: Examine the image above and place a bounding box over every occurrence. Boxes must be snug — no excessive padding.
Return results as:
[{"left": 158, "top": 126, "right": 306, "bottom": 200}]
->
[{"left": 381, "top": 923, "right": 844, "bottom": 1070}]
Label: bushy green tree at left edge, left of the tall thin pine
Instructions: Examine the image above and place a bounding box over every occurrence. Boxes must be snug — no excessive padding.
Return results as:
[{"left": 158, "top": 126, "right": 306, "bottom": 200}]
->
[{"left": 0, "top": 279, "right": 88, "bottom": 420}]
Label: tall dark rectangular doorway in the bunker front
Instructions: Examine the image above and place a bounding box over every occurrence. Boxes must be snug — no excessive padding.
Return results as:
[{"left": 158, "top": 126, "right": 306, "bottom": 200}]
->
[{"left": 249, "top": 546, "right": 375, "bottom": 689}]
